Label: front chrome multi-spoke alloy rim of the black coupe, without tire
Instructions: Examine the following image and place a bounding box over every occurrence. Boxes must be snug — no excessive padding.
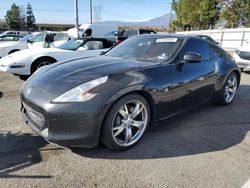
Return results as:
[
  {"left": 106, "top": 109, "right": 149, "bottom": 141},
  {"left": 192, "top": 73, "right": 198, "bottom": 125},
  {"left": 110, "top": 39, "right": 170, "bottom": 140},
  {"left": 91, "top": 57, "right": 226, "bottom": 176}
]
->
[{"left": 112, "top": 100, "right": 148, "bottom": 146}]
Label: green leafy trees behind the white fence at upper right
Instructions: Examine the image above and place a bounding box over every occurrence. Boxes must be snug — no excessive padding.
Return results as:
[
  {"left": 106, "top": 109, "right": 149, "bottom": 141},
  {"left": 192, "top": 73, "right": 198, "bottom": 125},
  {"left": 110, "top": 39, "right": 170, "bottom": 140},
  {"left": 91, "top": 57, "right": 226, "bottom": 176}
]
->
[{"left": 170, "top": 0, "right": 250, "bottom": 30}]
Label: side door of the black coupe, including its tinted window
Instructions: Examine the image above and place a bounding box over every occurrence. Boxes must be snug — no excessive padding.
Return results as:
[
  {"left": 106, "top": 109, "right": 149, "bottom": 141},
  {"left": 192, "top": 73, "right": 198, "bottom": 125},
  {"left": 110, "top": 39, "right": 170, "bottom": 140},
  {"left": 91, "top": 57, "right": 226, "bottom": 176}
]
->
[{"left": 172, "top": 38, "right": 216, "bottom": 109}]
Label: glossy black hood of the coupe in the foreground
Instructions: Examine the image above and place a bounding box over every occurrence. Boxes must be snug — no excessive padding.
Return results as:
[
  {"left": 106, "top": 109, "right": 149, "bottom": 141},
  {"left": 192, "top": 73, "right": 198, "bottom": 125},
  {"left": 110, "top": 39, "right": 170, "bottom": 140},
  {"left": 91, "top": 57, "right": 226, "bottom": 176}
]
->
[{"left": 27, "top": 56, "right": 156, "bottom": 96}]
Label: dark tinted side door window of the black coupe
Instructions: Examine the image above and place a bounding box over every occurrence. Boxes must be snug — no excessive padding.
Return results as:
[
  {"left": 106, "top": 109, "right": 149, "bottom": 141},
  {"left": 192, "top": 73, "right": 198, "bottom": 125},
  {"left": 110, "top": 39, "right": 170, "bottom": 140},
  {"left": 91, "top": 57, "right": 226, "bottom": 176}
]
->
[{"left": 182, "top": 39, "right": 211, "bottom": 60}]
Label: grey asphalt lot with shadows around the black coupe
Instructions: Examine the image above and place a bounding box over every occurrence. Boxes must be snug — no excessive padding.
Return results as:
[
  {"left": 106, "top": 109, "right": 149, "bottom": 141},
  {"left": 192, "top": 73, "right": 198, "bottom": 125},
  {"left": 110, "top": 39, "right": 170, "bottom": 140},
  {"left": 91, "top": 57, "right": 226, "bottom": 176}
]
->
[{"left": 0, "top": 72, "right": 250, "bottom": 188}]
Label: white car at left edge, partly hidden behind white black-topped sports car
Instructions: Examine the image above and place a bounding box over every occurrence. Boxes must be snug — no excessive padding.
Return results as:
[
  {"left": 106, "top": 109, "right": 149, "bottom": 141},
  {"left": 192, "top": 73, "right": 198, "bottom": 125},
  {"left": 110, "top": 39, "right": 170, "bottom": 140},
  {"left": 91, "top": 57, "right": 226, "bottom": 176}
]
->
[{"left": 0, "top": 33, "right": 36, "bottom": 58}]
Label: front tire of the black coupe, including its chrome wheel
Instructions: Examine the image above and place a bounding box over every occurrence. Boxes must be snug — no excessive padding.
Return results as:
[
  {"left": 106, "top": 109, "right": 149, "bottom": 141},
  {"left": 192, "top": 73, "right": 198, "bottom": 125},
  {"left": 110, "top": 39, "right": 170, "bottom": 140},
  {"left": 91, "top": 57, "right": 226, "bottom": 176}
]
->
[{"left": 101, "top": 94, "right": 150, "bottom": 150}]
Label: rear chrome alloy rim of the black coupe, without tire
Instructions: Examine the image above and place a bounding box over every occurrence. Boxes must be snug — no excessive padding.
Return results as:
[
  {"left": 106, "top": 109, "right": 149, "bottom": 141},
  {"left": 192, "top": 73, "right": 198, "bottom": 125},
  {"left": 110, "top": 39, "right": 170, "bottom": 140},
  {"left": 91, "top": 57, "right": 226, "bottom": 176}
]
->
[{"left": 224, "top": 74, "right": 238, "bottom": 103}]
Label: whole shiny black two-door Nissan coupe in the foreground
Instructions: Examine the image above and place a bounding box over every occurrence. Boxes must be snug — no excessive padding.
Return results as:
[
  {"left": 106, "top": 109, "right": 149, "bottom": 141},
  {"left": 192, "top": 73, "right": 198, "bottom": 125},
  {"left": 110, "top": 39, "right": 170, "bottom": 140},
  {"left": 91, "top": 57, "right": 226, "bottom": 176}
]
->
[{"left": 21, "top": 35, "right": 240, "bottom": 150}]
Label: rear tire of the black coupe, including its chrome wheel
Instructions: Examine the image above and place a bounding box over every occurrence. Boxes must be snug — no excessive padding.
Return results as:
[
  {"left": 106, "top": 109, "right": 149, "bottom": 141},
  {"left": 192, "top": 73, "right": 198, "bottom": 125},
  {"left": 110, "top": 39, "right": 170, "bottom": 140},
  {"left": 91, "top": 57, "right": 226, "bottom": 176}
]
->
[{"left": 219, "top": 72, "right": 239, "bottom": 105}]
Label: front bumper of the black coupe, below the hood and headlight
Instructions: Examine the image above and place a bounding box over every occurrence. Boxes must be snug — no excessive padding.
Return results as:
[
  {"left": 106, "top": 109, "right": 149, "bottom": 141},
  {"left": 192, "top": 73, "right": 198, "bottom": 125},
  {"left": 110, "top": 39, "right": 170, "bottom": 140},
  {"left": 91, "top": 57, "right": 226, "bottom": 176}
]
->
[{"left": 21, "top": 85, "right": 103, "bottom": 148}]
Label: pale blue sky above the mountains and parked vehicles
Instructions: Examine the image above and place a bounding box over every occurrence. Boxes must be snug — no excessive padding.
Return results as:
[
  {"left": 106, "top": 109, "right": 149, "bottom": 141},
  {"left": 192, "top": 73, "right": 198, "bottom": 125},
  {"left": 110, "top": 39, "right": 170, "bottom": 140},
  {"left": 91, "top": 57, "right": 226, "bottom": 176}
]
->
[{"left": 0, "top": 0, "right": 171, "bottom": 24}]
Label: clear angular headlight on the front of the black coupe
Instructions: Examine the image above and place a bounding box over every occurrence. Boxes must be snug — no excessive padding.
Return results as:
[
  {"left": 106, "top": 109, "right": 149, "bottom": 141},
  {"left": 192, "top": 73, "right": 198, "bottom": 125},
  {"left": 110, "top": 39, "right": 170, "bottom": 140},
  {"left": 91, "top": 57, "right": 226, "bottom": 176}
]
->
[{"left": 52, "top": 76, "right": 108, "bottom": 103}]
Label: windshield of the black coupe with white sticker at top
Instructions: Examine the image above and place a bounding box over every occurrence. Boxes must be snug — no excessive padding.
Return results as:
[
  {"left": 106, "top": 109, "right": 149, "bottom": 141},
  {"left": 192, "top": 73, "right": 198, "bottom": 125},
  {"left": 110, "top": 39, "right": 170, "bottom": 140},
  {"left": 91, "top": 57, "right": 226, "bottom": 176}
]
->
[{"left": 106, "top": 35, "right": 183, "bottom": 62}]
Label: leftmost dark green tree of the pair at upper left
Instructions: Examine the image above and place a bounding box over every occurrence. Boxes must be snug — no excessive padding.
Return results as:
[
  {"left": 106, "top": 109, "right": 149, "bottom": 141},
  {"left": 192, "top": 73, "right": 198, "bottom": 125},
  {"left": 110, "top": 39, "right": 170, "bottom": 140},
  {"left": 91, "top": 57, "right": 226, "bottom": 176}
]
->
[{"left": 5, "top": 3, "right": 22, "bottom": 30}]
